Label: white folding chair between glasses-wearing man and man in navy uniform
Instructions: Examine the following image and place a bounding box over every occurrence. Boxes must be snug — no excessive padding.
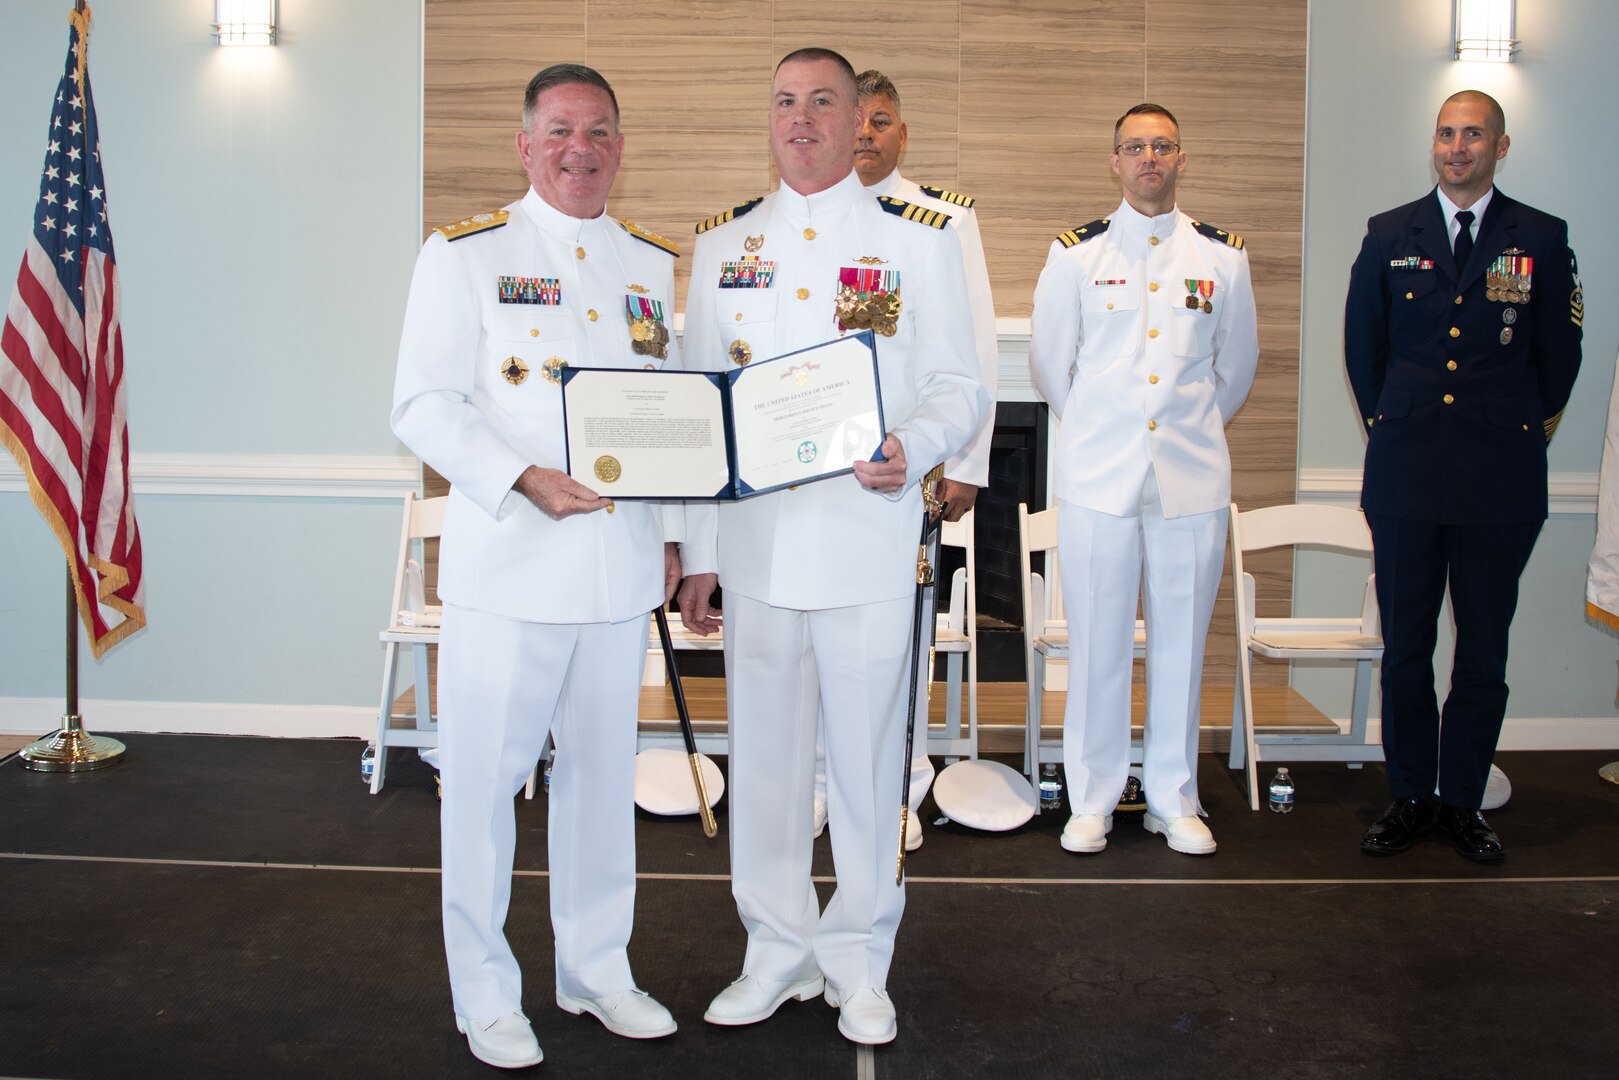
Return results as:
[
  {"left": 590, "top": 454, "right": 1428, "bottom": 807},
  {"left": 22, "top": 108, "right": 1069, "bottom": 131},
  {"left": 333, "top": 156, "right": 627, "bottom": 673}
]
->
[{"left": 1230, "top": 504, "right": 1383, "bottom": 810}]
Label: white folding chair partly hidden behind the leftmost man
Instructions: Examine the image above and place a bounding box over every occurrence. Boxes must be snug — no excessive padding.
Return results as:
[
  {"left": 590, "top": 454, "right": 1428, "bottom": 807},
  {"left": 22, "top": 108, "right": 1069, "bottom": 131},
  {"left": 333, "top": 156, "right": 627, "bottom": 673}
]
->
[{"left": 371, "top": 492, "right": 537, "bottom": 798}]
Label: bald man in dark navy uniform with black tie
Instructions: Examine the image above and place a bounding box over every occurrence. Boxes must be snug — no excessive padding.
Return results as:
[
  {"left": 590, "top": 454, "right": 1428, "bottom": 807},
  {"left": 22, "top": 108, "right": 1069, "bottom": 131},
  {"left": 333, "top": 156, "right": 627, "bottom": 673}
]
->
[{"left": 1344, "top": 91, "right": 1585, "bottom": 863}]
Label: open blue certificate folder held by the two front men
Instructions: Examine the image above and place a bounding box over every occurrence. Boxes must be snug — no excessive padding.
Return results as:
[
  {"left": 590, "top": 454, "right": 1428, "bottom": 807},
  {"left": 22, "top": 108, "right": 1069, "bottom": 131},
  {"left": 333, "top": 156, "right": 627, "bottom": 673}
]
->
[{"left": 562, "top": 330, "right": 887, "bottom": 500}]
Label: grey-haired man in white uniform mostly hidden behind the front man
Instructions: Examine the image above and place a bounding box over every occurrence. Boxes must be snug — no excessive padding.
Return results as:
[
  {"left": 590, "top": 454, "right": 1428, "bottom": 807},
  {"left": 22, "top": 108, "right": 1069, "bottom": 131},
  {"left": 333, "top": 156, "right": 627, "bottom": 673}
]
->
[{"left": 814, "top": 70, "right": 999, "bottom": 852}]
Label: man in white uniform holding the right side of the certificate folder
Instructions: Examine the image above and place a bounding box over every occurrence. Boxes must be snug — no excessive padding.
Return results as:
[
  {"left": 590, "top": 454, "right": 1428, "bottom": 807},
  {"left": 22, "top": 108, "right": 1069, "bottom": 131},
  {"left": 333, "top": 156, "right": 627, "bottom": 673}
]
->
[{"left": 680, "top": 49, "right": 988, "bottom": 1043}]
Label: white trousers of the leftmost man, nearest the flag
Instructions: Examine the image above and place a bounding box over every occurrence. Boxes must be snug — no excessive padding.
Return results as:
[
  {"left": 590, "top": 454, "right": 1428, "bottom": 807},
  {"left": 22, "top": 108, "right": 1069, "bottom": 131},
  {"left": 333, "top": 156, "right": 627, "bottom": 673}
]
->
[{"left": 439, "top": 604, "right": 648, "bottom": 1020}]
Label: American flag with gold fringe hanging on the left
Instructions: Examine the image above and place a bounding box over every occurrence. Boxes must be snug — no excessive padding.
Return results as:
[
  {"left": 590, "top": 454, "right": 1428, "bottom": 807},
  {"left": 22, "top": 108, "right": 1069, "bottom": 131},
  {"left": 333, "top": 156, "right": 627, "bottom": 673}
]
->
[{"left": 0, "top": 8, "right": 146, "bottom": 656}]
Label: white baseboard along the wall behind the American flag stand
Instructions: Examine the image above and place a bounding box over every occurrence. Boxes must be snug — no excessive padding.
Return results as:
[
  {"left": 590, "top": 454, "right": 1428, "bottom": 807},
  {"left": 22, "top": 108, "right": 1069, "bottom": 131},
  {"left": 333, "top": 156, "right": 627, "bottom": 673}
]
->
[{"left": 0, "top": 698, "right": 377, "bottom": 738}]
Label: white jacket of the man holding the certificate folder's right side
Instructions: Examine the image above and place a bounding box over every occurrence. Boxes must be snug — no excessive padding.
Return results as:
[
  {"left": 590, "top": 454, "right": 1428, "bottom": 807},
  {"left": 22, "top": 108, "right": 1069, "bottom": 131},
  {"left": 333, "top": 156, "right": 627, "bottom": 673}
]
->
[{"left": 682, "top": 172, "right": 989, "bottom": 610}]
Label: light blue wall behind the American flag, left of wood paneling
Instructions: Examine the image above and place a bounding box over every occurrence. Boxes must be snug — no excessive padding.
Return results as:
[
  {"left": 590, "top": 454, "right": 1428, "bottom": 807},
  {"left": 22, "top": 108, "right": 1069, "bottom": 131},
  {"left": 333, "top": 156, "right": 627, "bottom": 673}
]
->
[{"left": 0, "top": 0, "right": 423, "bottom": 727}]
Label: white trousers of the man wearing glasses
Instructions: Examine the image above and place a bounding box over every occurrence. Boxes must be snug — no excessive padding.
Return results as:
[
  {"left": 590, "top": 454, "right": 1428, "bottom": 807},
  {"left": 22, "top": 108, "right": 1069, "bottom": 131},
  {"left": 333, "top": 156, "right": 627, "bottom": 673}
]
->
[{"left": 1057, "top": 473, "right": 1229, "bottom": 818}]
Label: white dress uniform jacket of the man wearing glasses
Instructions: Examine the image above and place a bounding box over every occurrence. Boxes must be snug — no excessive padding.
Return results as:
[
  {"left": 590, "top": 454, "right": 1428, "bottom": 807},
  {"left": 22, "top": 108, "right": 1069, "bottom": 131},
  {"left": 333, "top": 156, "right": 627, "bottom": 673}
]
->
[{"left": 1030, "top": 201, "right": 1260, "bottom": 518}]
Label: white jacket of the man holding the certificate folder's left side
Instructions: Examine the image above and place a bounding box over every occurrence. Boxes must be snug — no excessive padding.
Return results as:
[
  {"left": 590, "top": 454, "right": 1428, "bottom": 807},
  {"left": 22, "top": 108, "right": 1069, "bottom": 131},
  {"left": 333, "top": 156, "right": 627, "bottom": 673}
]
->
[{"left": 393, "top": 189, "right": 677, "bottom": 623}]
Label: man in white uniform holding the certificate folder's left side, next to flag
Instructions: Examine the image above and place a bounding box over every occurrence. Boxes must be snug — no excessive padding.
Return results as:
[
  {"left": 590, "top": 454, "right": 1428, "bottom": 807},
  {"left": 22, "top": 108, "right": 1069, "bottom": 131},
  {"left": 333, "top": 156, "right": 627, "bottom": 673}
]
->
[{"left": 393, "top": 65, "right": 680, "bottom": 1069}]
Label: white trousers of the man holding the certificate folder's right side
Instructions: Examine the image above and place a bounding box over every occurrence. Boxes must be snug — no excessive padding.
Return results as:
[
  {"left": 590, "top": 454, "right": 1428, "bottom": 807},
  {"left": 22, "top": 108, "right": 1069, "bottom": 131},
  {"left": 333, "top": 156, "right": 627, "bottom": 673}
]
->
[{"left": 725, "top": 593, "right": 911, "bottom": 991}]
